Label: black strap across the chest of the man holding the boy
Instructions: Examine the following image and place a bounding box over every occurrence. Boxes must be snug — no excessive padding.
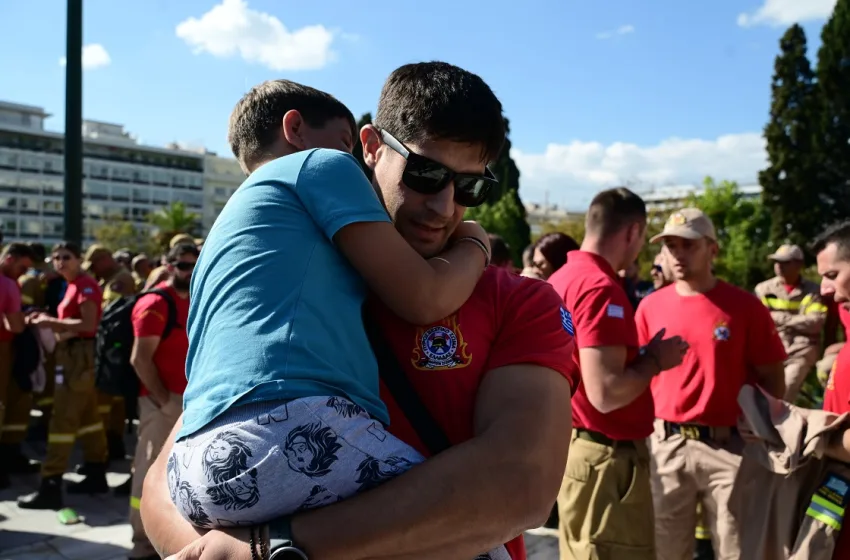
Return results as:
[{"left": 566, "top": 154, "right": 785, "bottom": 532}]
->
[{"left": 363, "top": 307, "right": 451, "bottom": 455}]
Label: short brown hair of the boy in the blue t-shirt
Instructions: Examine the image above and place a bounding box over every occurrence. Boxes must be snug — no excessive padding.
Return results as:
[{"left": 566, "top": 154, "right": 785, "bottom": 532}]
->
[{"left": 227, "top": 80, "right": 357, "bottom": 169}]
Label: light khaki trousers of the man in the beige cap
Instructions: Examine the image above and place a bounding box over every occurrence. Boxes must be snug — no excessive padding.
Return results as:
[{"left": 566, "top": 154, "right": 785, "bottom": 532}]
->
[{"left": 649, "top": 420, "right": 743, "bottom": 560}]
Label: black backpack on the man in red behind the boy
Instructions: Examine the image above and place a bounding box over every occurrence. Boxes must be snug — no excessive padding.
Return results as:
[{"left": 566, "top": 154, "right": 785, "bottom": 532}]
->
[{"left": 94, "top": 289, "right": 177, "bottom": 399}]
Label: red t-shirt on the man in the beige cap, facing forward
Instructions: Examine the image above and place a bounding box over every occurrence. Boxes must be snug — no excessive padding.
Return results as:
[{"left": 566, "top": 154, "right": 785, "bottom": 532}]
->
[{"left": 636, "top": 280, "right": 786, "bottom": 427}]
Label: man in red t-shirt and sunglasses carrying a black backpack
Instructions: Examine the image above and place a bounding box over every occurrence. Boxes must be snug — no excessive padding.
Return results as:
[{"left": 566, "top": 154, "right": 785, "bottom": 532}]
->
[{"left": 130, "top": 244, "right": 199, "bottom": 559}]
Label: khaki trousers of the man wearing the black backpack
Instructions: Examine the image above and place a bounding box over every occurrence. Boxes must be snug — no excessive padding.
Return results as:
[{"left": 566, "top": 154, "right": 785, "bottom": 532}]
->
[{"left": 130, "top": 393, "right": 183, "bottom": 558}]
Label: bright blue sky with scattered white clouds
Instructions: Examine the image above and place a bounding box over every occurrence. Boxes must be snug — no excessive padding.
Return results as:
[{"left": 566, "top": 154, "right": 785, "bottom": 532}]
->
[{"left": 0, "top": 0, "right": 835, "bottom": 208}]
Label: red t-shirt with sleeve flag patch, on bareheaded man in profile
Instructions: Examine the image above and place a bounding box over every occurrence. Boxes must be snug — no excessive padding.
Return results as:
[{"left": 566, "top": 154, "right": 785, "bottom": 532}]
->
[{"left": 549, "top": 251, "right": 655, "bottom": 440}]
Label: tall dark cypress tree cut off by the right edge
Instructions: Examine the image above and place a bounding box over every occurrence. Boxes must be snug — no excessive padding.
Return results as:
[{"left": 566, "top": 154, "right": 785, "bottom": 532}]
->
[{"left": 817, "top": 0, "right": 850, "bottom": 219}]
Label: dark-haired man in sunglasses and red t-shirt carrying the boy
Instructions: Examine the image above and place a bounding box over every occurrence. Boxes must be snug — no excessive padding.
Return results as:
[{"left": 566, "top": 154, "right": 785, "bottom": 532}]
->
[{"left": 142, "top": 62, "right": 578, "bottom": 560}]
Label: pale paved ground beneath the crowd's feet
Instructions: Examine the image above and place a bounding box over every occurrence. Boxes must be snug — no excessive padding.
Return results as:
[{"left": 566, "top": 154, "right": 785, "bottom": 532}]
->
[{"left": 0, "top": 430, "right": 558, "bottom": 560}]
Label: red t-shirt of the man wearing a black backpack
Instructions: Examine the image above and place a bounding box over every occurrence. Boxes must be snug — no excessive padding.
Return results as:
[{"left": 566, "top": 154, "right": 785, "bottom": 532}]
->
[{"left": 132, "top": 282, "right": 189, "bottom": 396}]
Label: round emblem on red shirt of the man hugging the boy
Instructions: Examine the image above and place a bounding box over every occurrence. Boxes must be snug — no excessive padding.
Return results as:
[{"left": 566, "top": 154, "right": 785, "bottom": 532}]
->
[{"left": 410, "top": 315, "right": 472, "bottom": 371}]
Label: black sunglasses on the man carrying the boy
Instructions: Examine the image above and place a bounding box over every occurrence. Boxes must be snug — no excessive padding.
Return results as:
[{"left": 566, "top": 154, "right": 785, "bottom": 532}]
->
[{"left": 381, "top": 130, "right": 499, "bottom": 208}]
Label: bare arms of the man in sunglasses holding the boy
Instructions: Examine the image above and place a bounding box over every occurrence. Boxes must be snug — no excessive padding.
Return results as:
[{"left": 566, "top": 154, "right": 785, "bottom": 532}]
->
[{"left": 142, "top": 365, "right": 572, "bottom": 560}]
